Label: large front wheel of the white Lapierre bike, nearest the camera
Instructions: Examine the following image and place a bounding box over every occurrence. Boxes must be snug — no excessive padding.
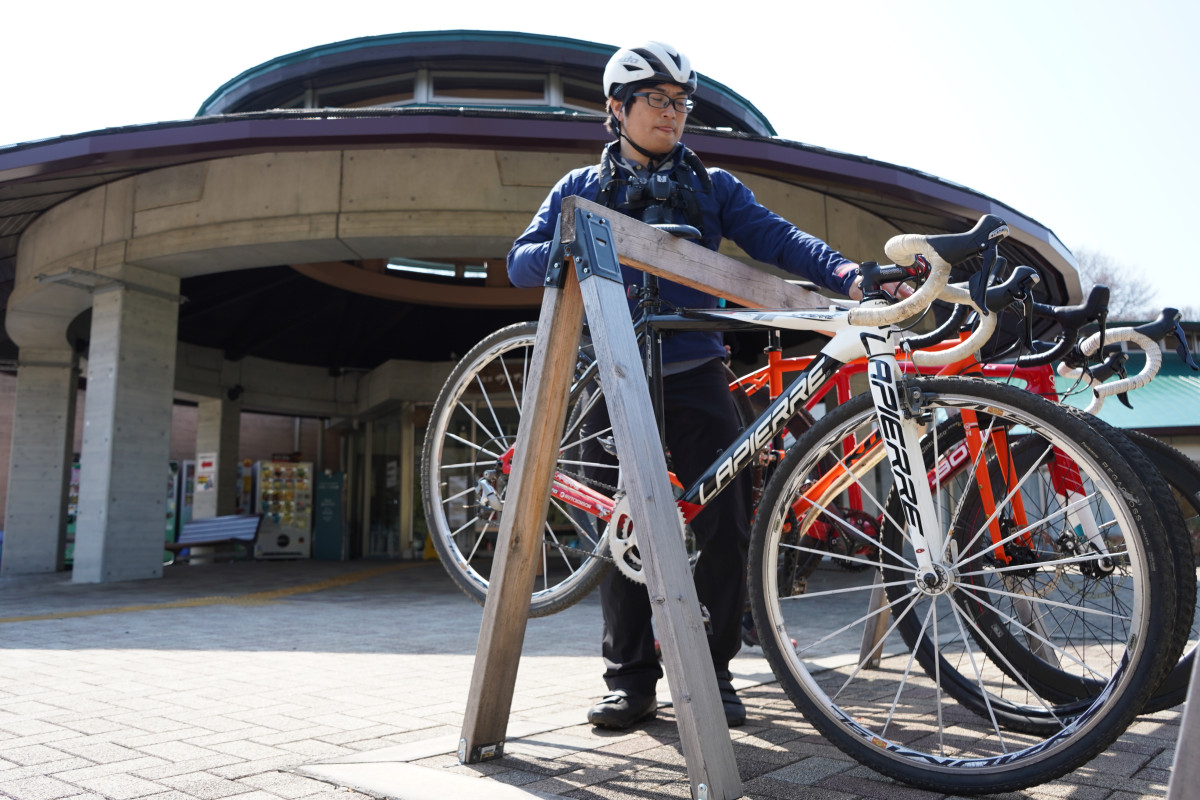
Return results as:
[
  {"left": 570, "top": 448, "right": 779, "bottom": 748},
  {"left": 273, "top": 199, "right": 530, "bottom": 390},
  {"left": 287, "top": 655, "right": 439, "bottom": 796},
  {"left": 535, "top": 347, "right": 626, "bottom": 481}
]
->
[{"left": 750, "top": 378, "right": 1175, "bottom": 794}]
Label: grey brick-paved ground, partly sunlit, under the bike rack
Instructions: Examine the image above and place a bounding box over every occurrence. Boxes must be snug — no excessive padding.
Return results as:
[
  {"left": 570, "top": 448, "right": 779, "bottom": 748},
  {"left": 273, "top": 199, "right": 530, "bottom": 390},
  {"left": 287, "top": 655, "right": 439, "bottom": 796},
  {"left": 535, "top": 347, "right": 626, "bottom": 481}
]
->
[{"left": 0, "top": 561, "right": 1180, "bottom": 800}]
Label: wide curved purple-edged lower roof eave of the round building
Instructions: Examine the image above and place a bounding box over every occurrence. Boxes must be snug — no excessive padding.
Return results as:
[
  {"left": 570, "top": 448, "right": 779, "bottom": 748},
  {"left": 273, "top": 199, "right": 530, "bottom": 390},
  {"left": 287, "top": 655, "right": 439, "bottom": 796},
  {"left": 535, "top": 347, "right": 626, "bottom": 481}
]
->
[{"left": 0, "top": 108, "right": 1080, "bottom": 376}]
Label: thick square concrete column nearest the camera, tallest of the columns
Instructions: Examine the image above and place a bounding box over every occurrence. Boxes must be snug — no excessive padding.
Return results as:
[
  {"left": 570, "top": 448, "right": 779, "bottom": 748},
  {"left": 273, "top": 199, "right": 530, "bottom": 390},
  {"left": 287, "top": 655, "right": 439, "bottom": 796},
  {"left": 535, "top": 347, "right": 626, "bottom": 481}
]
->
[{"left": 72, "top": 267, "right": 179, "bottom": 583}]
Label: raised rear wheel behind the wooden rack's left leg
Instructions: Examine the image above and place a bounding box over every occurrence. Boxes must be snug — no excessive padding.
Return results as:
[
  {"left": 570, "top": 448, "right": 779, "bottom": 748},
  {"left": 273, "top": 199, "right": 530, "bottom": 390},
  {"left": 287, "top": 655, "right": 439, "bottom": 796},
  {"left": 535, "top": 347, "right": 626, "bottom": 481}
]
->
[{"left": 421, "top": 323, "right": 611, "bottom": 616}]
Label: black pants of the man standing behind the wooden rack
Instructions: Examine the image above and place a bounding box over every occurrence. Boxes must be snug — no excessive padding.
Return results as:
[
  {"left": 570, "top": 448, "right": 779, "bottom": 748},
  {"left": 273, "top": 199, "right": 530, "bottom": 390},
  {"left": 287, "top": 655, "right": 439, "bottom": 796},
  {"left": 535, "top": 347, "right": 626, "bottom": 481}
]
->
[{"left": 584, "top": 360, "right": 750, "bottom": 693}]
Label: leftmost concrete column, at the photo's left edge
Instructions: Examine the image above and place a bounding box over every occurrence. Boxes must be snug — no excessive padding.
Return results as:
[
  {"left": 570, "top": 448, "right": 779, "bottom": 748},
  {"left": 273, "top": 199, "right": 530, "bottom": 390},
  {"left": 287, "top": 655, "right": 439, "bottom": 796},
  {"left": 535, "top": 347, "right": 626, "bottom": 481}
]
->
[{"left": 0, "top": 347, "right": 79, "bottom": 575}]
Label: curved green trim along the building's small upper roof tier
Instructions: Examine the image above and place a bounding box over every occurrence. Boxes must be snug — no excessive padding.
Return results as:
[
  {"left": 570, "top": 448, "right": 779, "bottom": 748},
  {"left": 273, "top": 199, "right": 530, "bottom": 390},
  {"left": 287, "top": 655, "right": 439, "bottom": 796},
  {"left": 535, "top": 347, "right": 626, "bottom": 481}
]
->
[{"left": 196, "top": 30, "right": 778, "bottom": 136}]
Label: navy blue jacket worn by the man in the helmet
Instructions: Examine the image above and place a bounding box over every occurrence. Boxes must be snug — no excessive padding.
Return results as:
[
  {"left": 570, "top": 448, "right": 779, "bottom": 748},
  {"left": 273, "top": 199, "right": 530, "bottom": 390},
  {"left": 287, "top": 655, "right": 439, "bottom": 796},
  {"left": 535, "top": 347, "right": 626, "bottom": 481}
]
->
[{"left": 508, "top": 144, "right": 854, "bottom": 363}]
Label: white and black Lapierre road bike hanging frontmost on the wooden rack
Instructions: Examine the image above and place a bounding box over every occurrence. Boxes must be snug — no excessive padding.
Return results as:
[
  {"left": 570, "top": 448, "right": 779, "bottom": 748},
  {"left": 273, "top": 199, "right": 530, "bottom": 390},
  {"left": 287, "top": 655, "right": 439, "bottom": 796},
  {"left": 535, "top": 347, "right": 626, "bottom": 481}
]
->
[{"left": 425, "top": 216, "right": 1178, "bottom": 792}]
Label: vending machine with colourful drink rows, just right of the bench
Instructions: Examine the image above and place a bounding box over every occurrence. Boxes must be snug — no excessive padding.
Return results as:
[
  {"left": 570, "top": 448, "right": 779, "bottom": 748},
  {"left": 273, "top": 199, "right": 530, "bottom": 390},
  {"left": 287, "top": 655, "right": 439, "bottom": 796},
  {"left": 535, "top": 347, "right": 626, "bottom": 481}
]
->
[{"left": 254, "top": 461, "right": 313, "bottom": 559}]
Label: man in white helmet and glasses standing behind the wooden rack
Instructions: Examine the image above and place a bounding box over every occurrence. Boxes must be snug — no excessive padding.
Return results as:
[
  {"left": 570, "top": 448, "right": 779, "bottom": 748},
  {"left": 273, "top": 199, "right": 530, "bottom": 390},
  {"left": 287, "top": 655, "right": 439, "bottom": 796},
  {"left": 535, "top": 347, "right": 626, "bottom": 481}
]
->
[{"left": 508, "top": 42, "right": 860, "bottom": 729}]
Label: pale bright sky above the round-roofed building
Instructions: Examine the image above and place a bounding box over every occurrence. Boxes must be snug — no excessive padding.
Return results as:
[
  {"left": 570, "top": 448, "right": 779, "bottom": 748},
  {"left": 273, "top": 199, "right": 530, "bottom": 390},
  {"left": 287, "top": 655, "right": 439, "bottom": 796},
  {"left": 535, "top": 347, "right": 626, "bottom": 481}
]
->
[{"left": 9, "top": 0, "right": 1200, "bottom": 311}]
